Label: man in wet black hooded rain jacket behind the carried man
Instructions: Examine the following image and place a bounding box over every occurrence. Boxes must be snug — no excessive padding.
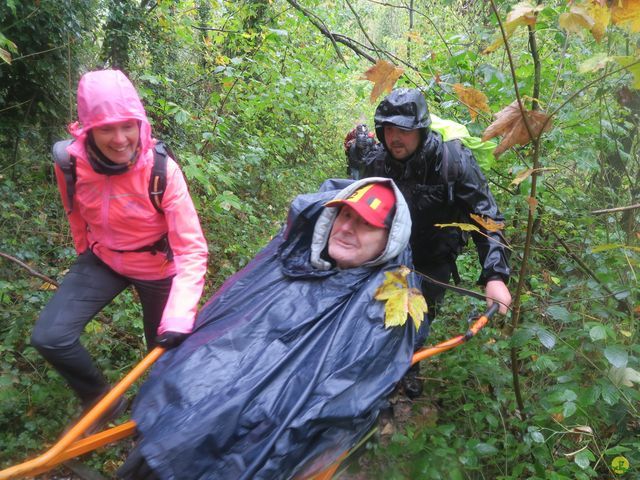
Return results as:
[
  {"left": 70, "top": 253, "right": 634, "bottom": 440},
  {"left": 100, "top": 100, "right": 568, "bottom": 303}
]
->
[{"left": 364, "top": 88, "right": 511, "bottom": 354}]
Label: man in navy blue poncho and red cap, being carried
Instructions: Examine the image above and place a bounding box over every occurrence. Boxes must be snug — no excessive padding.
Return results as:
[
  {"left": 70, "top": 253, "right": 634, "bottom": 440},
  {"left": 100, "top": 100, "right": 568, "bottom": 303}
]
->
[{"left": 119, "top": 178, "right": 416, "bottom": 480}]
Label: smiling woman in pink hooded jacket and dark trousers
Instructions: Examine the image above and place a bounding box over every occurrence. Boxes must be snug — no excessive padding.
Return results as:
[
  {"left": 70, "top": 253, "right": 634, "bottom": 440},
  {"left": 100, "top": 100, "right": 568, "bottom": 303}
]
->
[{"left": 31, "top": 70, "right": 207, "bottom": 420}]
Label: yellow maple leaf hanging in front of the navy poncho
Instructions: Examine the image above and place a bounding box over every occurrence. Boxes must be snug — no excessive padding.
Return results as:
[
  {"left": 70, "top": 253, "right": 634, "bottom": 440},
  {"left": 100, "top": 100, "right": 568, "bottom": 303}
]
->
[{"left": 374, "top": 266, "right": 428, "bottom": 330}]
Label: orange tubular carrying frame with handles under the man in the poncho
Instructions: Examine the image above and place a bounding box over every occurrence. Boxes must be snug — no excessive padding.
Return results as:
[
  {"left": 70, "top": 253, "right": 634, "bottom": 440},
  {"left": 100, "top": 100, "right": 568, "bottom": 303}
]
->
[{"left": 0, "top": 303, "right": 498, "bottom": 480}]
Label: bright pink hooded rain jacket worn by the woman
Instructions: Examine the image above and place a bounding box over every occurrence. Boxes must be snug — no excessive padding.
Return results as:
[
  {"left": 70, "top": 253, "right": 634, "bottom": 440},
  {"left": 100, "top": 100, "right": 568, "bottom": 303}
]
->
[{"left": 56, "top": 70, "right": 207, "bottom": 333}]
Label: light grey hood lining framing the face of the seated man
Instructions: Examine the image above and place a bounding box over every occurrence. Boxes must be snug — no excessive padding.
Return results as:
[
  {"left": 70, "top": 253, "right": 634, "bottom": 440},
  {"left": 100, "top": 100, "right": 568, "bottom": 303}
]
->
[{"left": 311, "top": 177, "right": 411, "bottom": 270}]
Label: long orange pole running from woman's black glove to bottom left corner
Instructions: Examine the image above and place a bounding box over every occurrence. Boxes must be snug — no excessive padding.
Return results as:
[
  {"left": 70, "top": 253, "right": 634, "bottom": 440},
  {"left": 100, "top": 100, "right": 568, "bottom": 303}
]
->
[{"left": 0, "top": 347, "right": 164, "bottom": 480}]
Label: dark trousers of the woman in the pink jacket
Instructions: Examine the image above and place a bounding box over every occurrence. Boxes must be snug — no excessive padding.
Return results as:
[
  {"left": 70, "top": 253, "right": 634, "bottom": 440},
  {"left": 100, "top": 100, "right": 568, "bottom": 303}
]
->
[{"left": 31, "top": 251, "right": 172, "bottom": 407}]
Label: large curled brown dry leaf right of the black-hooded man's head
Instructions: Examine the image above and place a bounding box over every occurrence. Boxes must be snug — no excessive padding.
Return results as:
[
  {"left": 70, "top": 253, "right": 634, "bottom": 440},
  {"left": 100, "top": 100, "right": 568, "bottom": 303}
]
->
[{"left": 482, "top": 100, "right": 552, "bottom": 157}]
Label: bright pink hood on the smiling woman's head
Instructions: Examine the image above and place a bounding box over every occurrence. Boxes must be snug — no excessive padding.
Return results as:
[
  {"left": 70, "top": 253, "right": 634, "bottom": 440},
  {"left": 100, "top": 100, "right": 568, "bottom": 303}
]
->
[{"left": 69, "top": 70, "right": 153, "bottom": 154}]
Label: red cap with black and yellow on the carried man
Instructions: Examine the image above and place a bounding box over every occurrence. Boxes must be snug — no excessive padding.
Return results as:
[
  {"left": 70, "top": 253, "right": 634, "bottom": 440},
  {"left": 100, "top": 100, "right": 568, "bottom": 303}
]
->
[{"left": 325, "top": 183, "right": 396, "bottom": 228}]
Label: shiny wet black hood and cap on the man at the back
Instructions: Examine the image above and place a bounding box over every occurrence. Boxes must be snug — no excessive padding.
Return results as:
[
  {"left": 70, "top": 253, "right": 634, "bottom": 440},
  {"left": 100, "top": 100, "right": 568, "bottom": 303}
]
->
[{"left": 373, "top": 88, "right": 431, "bottom": 148}]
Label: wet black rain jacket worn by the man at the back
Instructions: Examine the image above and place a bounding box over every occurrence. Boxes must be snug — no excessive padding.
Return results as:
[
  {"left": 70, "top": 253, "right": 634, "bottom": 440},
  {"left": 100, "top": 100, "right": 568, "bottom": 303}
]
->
[{"left": 364, "top": 129, "right": 510, "bottom": 290}]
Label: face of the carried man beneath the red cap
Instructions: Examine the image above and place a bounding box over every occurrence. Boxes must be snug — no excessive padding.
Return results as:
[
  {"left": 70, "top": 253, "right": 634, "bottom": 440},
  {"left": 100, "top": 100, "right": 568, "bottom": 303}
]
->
[{"left": 329, "top": 205, "right": 389, "bottom": 269}]
